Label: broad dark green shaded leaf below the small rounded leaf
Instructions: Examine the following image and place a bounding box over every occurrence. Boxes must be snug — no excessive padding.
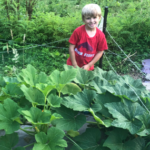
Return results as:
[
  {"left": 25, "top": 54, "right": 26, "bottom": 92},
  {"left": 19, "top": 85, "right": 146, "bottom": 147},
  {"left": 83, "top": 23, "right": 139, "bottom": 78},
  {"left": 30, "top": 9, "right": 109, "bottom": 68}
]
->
[{"left": 53, "top": 107, "right": 86, "bottom": 131}]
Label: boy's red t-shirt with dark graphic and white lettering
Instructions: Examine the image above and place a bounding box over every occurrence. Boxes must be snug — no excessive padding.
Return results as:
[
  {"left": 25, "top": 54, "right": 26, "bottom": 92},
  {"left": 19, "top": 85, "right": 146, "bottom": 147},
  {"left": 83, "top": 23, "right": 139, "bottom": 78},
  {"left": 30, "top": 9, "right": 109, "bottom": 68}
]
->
[{"left": 67, "top": 25, "right": 108, "bottom": 70}]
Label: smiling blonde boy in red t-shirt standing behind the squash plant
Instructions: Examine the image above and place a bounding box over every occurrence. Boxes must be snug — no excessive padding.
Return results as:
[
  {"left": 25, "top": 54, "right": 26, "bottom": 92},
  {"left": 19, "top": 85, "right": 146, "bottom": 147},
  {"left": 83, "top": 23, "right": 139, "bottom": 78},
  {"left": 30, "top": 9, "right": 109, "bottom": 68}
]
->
[{"left": 67, "top": 4, "right": 108, "bottom": 70}]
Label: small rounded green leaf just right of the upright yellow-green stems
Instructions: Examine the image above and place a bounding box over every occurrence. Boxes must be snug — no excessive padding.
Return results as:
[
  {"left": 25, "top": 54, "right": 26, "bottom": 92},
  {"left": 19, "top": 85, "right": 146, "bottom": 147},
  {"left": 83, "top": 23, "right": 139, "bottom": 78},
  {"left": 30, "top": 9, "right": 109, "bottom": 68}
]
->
[{"left": 47, "top": 94, "right": 62, "bottom": 107}]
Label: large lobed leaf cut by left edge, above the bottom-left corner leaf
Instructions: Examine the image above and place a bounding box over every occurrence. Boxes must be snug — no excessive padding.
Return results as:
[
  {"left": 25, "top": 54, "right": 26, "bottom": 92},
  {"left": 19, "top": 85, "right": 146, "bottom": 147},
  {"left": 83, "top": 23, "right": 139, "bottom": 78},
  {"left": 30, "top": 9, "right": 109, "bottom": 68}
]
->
[{"left": 0, "top": 99, "right": 20, "bottom": 134}]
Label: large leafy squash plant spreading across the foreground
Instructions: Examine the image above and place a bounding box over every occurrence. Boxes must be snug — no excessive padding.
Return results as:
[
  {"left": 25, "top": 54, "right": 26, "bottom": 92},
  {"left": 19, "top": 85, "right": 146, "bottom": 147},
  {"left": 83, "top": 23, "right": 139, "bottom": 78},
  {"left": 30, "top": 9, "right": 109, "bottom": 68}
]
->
[{"left": 0, "top": 65, "right": 150, "bottom": 150}]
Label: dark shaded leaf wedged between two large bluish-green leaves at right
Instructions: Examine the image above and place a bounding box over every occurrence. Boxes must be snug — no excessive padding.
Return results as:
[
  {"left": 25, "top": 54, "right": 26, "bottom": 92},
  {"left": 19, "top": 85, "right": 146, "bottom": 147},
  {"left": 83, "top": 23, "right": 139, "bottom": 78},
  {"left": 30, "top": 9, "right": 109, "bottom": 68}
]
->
[{"left": 96, "top": 92, "right": 121, "bottom": 117}]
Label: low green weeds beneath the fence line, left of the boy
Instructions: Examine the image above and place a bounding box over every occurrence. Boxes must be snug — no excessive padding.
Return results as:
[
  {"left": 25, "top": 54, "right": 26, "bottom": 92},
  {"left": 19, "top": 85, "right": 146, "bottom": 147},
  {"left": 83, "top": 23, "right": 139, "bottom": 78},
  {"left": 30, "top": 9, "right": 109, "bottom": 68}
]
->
[{"left": 0, "top": 40, "right": 69, "bottom": 76}]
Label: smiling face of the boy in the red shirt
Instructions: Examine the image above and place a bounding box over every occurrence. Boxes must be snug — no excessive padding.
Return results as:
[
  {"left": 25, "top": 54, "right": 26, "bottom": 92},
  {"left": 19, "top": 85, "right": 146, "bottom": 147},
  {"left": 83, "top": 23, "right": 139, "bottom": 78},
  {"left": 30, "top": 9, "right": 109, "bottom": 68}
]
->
[{"left": 83, "top": 16, "right": 101, "bottom": 30}]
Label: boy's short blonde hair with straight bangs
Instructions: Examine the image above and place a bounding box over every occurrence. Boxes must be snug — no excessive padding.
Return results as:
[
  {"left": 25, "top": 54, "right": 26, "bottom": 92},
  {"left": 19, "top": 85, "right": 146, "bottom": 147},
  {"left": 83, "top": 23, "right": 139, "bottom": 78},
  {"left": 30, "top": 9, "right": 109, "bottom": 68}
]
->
[{"left": 82, "top": 4, "right": 101, "bottom": 21}]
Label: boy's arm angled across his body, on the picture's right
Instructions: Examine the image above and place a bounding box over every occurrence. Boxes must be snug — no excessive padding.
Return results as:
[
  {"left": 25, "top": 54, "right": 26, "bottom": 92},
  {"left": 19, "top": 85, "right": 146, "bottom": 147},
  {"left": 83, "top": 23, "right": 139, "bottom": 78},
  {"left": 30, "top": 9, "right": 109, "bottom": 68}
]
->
[{"left": 82, "top": 51, "right": 103, "bottom": 70}]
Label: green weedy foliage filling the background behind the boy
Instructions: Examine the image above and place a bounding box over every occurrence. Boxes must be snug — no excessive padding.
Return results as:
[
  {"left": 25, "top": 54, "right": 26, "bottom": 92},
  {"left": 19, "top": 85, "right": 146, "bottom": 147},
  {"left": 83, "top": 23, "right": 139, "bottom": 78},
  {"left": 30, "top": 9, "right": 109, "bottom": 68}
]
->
[{"left": 0, "top": 0, "right": 150, "bottom": 75}]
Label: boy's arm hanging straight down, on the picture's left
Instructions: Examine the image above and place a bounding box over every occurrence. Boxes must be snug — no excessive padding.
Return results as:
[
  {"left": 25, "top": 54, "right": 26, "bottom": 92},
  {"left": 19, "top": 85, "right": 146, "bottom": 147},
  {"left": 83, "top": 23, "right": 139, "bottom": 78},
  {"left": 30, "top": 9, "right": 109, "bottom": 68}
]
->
[{"left": 69, "top": 44, "right": 78, "bottom": 67}]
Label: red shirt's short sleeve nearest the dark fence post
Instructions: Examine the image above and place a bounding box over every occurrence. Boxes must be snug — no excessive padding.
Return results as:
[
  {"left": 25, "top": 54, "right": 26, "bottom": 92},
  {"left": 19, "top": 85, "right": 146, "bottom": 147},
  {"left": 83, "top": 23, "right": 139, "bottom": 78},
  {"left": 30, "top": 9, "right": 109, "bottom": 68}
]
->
[{"left": 97, "top": 34, "right": 108, "bottom": 51}]
